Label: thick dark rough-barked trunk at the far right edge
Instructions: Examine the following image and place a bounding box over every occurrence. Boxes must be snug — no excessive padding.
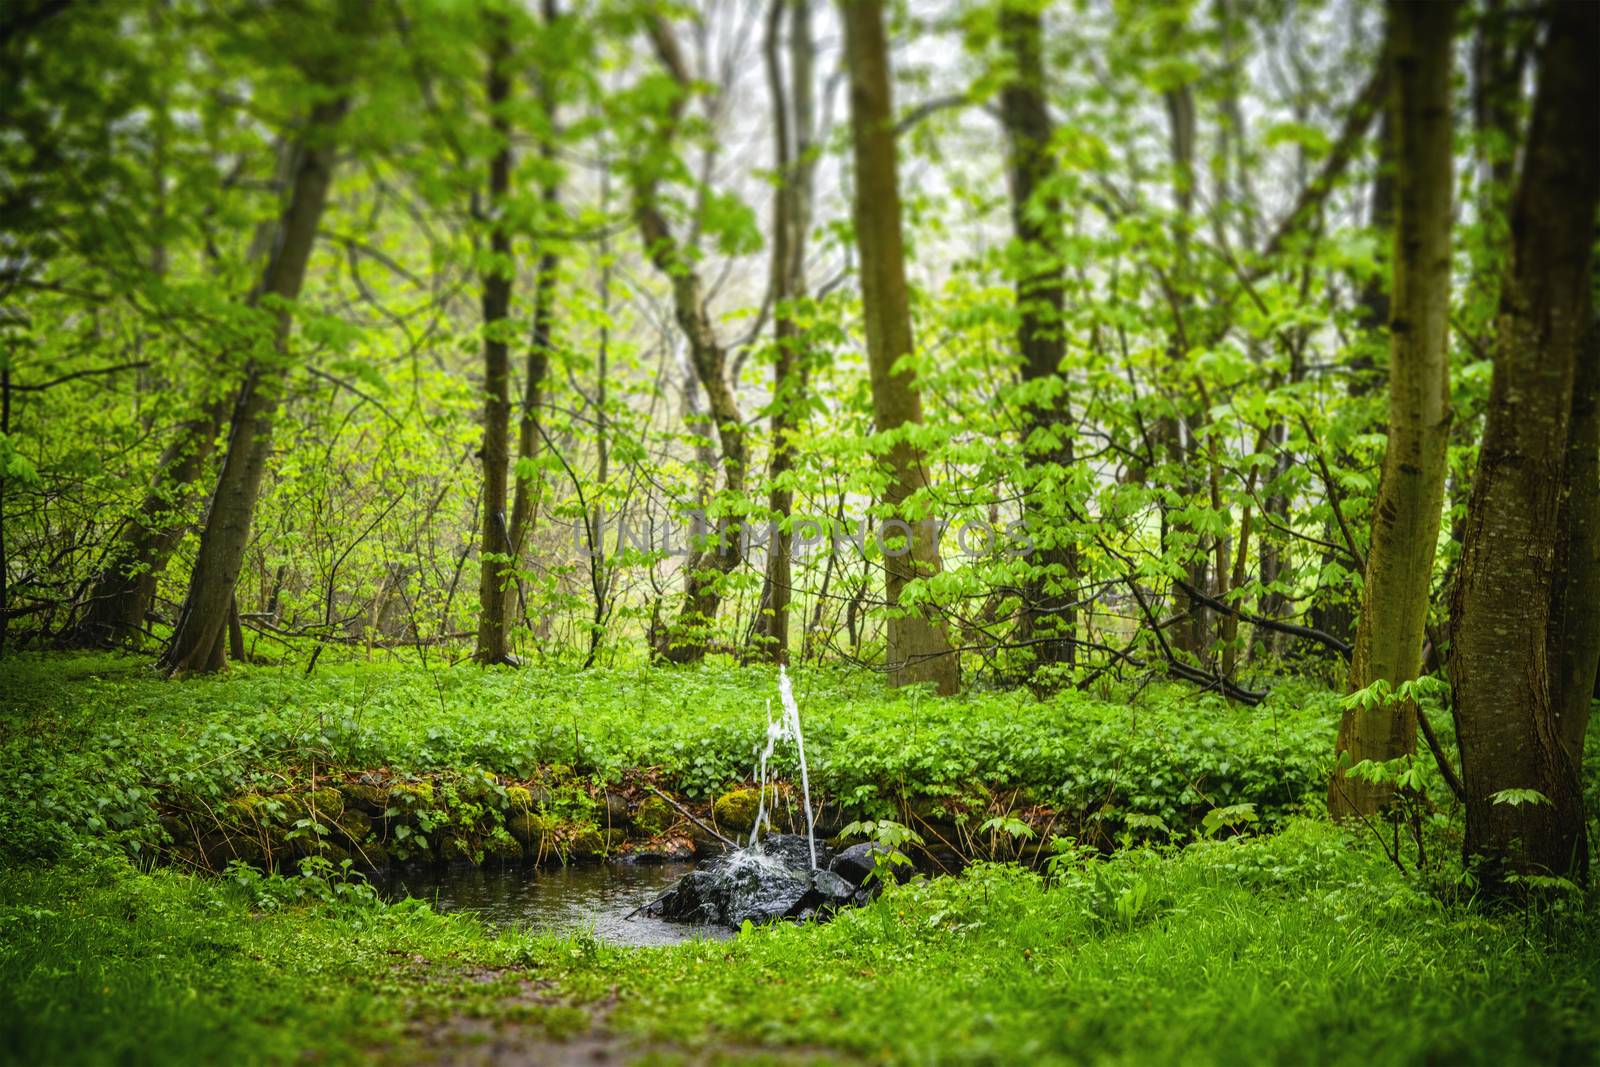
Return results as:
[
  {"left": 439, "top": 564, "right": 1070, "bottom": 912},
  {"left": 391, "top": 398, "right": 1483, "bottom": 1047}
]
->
[{"left": 1450, "top": 3, "right": 1600, "bottom": 891}]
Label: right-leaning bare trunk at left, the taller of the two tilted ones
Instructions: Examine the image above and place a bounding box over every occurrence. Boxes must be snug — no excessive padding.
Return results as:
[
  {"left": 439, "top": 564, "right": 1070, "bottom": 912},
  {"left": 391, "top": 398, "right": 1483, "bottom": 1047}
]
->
[{"left": 162, "top": 98, "right": 346, "bottom": 673}]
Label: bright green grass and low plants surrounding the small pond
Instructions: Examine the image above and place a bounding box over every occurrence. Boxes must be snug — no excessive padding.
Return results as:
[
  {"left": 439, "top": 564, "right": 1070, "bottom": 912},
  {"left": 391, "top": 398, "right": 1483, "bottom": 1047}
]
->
[{"left": 0, "top": 656, "right": 1600, "bottom": 1064}]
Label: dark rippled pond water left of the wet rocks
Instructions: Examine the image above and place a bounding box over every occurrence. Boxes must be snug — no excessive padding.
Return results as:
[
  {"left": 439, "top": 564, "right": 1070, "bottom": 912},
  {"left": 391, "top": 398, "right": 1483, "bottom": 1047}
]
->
[{"left": 373, "top": 864, "right": 731, "bottom": 945}]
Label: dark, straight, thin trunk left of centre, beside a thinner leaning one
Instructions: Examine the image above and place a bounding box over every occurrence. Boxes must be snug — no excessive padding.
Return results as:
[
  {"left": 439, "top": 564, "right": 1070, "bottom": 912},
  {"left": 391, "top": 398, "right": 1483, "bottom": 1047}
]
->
[{"left": 472, "top": 18, "right": 517, "bottom": 664}]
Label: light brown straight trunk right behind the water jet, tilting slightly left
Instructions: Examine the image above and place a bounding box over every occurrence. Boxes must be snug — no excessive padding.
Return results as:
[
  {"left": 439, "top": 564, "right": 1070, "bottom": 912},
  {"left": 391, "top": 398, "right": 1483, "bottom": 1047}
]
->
[{"left": 840, "top": 0, "right": 960, "bottom": 694}]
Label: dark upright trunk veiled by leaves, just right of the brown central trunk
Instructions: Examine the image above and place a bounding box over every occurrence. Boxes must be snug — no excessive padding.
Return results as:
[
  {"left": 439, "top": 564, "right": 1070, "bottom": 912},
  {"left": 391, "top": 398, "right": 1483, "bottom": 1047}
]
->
[{"left": 1000, "top": 2, "right": 1078, "bottom": 673}]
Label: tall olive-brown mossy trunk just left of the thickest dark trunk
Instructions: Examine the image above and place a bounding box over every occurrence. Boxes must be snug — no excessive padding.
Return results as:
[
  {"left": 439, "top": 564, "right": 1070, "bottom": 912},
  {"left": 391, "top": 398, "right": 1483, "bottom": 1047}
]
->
[{"left": 1328, "top": 3, "right": 1456, "bottom": 817}]
